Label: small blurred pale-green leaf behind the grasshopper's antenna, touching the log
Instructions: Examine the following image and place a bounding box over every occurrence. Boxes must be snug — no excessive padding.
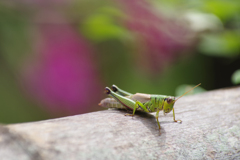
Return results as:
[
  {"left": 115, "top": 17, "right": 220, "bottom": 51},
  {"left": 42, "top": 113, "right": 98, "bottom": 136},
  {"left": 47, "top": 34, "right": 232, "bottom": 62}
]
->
[{"left": 175, "top": 84, "right": 206, "bottom": 96}]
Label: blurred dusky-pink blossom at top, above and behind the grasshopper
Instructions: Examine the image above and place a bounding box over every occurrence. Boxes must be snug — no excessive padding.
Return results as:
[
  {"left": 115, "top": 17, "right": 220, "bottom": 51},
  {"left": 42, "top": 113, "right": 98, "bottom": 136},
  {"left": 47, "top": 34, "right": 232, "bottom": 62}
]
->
[{"left": 118, "top": 0, "right": 193, "bottom": 70}]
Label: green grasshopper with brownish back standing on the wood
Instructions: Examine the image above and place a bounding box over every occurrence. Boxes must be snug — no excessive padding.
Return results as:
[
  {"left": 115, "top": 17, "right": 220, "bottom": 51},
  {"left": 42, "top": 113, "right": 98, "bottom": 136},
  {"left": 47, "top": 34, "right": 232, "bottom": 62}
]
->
[{"left": 99, "top": 83, "right": 201, "bottom": 130}]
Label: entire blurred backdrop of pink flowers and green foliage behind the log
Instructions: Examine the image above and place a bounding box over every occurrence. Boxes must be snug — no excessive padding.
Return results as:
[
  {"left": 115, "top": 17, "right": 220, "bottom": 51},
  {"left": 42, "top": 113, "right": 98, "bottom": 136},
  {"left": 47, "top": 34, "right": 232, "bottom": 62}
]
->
[{"left": 0, "top": 0, "right": 240, "bottom": 123}]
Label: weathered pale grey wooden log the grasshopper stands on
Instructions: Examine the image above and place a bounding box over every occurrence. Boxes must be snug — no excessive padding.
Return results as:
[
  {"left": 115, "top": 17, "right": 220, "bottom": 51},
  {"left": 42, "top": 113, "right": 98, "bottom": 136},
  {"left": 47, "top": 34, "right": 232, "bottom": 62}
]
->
[{"left": 0, "top": 87, "right": 240, "bottom": 160}]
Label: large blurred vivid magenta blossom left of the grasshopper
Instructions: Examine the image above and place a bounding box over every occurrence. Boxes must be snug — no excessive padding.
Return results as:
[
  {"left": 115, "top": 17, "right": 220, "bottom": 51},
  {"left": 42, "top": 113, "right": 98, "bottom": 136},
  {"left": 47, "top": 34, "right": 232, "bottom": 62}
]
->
[{"left": 24, "top": 23, "right": 102, "bottom": 115}]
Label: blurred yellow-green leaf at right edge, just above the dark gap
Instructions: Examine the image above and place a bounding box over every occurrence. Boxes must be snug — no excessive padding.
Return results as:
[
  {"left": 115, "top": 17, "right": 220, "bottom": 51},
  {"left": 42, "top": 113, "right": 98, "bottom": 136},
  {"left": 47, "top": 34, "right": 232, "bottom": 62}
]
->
[{"left": 199, "top": 31, "right": 240, "bottom": 58}]
